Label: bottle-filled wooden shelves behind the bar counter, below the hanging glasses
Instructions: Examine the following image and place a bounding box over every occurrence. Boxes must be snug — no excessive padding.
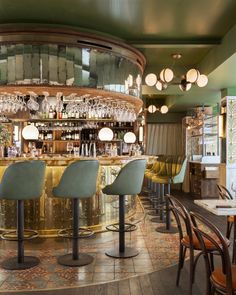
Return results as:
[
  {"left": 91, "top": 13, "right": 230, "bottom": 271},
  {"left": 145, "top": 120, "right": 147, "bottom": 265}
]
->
[{"left": 24, "top": 121, "right": 134, "bottom": 157}]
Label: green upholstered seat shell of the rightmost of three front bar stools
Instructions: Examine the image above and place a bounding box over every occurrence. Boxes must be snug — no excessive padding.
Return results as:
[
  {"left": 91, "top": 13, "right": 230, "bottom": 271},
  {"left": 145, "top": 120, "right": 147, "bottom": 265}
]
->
[{"left": 103, "top": 159, "right": 146, "bottom": 195}]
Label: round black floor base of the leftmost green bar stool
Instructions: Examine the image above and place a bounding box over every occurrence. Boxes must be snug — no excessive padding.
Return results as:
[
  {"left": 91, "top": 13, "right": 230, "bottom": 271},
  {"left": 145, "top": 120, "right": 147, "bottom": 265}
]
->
[{"left": 1, "top": 256, "right": 40, "bottom": 270}]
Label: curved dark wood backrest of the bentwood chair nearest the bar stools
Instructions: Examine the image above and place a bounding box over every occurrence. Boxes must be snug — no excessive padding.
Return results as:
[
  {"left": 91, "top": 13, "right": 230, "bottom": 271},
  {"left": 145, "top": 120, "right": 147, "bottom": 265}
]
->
[{"left": 166, "top": 195, "right": 193, "bottom": 249}]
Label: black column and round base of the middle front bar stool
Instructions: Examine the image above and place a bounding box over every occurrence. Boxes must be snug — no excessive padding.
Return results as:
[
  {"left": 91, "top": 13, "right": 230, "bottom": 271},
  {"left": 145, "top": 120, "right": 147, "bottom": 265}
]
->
[{"left": 57, "top": 198, "right": 93, "bottom": 266}]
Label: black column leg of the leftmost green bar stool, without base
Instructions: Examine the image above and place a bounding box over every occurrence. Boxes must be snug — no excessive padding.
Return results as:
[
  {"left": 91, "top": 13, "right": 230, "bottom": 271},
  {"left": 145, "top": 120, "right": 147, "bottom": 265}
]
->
[{"left": 17, "top": 200, "right": 24, "bottom": 263}]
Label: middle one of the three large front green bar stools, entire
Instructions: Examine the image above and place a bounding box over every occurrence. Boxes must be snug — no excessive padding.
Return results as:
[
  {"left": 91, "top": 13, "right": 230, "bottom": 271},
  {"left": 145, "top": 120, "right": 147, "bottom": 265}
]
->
[{"left": 53, "top": 160, "right": 99, "bottom": 266}]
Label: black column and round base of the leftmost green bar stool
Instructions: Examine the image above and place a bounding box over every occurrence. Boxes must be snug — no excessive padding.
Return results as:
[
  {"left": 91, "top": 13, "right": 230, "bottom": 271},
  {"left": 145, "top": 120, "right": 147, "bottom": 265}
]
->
[{"left": 1, "top": 200, "right": 40, "bottom": 270}]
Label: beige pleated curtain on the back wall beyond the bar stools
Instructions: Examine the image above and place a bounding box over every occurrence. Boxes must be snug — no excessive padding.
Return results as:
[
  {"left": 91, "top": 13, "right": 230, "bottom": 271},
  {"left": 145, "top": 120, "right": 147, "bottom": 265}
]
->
[{"left": 147, "top": 124, "right": 184, "bottom": 155}]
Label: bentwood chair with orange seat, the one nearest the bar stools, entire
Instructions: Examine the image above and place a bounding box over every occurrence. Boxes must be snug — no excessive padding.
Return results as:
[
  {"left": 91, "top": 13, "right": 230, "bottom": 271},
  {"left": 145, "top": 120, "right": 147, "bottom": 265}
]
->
[{"left": 166, "top": 195, "right": 229, "bottom": 294}]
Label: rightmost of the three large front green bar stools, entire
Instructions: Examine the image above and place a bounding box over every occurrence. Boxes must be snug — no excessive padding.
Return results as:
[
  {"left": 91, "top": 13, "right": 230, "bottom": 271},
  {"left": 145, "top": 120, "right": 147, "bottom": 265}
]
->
[{"left": 102, "top": 159, "right": 146, "bottom": 258}]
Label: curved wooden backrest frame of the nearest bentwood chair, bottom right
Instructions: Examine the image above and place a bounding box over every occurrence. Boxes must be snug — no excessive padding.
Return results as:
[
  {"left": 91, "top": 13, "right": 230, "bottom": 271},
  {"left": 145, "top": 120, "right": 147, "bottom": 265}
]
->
[{"left": 190, "top": 212, "right": 234, "bottom": 295}]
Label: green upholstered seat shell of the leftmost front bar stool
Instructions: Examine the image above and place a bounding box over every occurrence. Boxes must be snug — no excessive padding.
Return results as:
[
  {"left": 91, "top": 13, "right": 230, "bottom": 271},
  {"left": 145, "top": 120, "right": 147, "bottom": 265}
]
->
[{"left": 0, "top": 161, "right": 46, "bottom": 200}]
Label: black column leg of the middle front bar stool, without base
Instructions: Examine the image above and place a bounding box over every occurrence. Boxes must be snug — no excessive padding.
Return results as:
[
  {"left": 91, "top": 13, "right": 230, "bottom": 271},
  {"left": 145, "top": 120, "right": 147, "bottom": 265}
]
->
[{"left": 72, "top": 198, "right": 79, "bottom": 260}]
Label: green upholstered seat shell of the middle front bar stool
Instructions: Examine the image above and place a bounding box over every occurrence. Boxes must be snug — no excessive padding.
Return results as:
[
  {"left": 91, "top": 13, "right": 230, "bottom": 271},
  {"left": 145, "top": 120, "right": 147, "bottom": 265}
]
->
[{"left": 53, "top": 160, "right": 99, "bottom": 198}]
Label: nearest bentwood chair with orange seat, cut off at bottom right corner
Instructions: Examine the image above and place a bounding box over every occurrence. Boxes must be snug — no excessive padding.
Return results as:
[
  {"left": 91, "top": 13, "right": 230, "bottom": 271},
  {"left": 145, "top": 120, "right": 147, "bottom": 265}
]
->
[{"left": 190, "top": 212, "right": 236, "bottom": 295}]
